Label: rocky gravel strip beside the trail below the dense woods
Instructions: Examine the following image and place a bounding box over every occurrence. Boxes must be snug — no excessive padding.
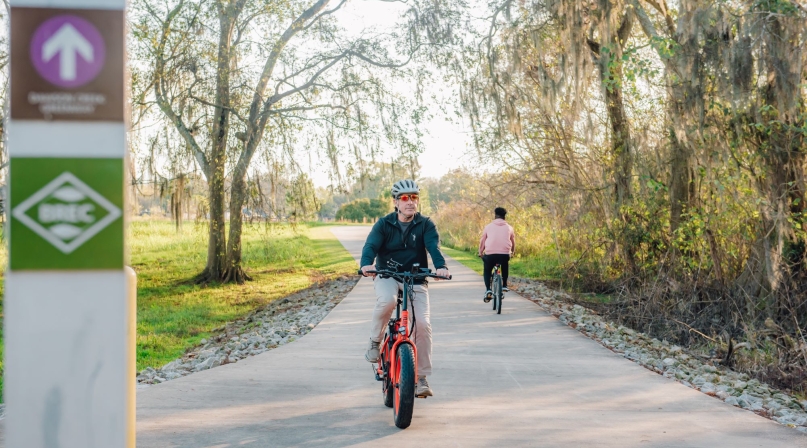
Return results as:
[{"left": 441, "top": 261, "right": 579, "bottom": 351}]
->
[{"left": 508, "top": 278, "right": 807, "bottom": 433}]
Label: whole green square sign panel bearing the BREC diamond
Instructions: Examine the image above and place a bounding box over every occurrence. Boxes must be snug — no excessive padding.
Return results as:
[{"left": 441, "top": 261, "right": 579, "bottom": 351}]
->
[{"left": 10, "top": 158, "right": 123, "bottom": 269}]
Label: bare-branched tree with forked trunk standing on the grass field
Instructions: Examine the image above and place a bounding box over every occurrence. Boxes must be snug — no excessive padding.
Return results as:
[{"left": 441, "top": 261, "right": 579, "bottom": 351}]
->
[{"left": 131, "top": 0, "right": 456, "bottom": 283}]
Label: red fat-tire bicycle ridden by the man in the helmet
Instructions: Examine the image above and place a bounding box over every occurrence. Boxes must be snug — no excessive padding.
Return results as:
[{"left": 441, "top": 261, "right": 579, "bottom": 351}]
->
[{"left": 359, "top": 263, "right": 451, "bottom": 429}]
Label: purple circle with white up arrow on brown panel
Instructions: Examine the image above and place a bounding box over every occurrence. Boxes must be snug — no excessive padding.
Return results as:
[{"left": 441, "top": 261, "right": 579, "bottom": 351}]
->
[{"left": 30, "top": 14, "right": 106, "bottom": 88}]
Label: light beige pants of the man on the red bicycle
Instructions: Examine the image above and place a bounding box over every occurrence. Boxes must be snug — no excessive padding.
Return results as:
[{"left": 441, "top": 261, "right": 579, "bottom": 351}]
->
[{"left": 370, "top": 276, "right": 432, "bottom": 376}]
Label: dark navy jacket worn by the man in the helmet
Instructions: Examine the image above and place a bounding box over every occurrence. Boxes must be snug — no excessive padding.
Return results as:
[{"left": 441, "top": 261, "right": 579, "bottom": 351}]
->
[{"left": 361, "top": 212, "right": 446, "bottom": 280}]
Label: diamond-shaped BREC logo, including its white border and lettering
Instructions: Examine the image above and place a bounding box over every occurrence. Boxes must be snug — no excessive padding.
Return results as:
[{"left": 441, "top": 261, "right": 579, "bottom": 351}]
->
[{"left": 12, "top": 172, "right": 121, "bottom": 254}]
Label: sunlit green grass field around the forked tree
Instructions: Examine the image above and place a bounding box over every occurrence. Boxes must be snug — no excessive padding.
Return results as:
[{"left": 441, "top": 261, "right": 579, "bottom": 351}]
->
[{"left": 0, "top": 220, "right": 356, "bottom": 400}]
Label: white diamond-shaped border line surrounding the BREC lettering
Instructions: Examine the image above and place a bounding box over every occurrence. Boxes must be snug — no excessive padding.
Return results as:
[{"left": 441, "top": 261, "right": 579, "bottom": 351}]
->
[{"left": 11, "top": 171, "right": 122, "bottom": 254}]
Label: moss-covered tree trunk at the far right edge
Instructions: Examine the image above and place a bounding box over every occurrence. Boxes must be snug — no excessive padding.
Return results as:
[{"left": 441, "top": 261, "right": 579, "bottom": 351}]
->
[{"left": 738, "top": 16, "right": 807, "bottom": 300}]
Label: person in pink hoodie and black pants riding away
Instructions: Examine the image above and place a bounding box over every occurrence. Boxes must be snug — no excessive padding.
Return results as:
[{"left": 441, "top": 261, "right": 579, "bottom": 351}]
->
[{"left": 479, "top": 207, "right": 516, "bottom": 303}]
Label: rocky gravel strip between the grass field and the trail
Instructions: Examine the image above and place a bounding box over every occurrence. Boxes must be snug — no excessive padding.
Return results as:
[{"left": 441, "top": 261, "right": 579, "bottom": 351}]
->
[{"left": 137, "top": 276, "right": 359, "bottom": 389}]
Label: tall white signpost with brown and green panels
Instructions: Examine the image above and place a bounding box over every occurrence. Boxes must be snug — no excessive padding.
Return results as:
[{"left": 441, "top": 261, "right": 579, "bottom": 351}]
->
[{"left": 4, "top": 0, "right": 135, "bottom": 448}]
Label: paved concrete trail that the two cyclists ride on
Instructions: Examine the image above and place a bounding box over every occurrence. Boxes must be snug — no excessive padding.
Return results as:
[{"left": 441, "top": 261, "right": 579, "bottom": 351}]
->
[{"left": 131, "top": 227, "right": 807, "bottom": 448}]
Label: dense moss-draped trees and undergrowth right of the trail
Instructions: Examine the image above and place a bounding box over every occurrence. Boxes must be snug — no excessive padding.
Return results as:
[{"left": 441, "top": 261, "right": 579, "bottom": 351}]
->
[{"left": 446, "top": 0, "right": 807, "bottom": 387}]
